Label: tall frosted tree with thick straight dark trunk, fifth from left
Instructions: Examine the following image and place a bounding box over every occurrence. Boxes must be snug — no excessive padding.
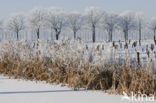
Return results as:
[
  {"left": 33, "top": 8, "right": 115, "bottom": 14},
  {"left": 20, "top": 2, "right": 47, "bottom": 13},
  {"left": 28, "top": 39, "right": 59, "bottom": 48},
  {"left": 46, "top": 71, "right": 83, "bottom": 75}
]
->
[{"left": 85, "top": 7, "right": 103, "bottom": 42}]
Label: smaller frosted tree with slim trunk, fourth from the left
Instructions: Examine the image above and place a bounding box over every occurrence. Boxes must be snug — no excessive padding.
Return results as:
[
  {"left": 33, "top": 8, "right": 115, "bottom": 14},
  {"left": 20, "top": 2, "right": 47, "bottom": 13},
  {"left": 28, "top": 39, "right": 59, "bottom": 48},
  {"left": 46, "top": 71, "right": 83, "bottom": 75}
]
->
[{"left": 68, "top": 12, "right": 83, "bottom": 39}]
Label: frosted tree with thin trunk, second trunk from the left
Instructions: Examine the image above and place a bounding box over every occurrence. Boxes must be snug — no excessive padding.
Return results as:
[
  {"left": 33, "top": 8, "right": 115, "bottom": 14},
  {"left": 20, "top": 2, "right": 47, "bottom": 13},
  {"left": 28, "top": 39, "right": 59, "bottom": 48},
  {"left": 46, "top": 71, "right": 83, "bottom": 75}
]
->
[{"left": 29, "top": 7, "right": 45, "bottom": 39}]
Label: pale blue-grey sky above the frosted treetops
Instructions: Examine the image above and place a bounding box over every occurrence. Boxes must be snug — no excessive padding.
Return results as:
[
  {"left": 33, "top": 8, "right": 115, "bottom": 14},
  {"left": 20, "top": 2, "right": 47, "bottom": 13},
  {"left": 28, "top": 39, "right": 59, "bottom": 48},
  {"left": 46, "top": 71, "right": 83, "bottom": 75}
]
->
[{"left": 0, "top": 0, "right": 156, "bottom": 18}]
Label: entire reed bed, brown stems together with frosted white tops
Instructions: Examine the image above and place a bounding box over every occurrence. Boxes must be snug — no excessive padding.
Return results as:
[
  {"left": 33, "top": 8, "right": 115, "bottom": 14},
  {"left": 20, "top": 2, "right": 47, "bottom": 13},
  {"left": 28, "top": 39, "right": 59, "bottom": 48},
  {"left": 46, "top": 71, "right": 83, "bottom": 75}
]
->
[{"left": 0, "top": 40, "right": 156, "bottom": 97}]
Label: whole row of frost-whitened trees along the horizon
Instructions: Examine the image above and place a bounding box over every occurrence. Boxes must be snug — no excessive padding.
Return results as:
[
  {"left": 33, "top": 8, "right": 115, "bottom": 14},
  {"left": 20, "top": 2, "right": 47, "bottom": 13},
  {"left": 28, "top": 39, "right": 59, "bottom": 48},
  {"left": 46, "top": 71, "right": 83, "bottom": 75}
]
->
[{"left": 0, "top": 7, "right": 156, "bottom": 42}]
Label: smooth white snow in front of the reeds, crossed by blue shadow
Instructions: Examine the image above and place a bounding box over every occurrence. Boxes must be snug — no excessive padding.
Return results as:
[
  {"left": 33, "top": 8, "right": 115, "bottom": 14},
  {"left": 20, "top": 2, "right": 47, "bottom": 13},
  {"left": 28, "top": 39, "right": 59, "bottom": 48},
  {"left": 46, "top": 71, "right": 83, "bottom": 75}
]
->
[{"left": 0, "top": 76, "right": 154, "bottom": 103}]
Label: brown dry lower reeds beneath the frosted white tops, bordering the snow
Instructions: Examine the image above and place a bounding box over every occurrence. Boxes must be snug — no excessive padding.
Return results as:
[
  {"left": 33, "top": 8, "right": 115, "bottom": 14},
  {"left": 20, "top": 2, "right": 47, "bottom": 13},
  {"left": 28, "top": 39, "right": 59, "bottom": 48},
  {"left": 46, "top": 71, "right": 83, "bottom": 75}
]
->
[{"left": 0, "top": 39, "right": 156, "bottom": 97}]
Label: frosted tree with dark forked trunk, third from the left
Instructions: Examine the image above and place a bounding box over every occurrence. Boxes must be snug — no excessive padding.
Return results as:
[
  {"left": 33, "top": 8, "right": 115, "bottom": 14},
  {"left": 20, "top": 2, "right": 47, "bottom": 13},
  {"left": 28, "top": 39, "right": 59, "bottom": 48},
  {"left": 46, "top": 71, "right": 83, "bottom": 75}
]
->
[{"left": 46, "top": 7, "right": 66, "bottom": 40}]
